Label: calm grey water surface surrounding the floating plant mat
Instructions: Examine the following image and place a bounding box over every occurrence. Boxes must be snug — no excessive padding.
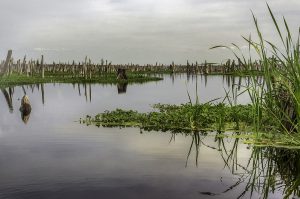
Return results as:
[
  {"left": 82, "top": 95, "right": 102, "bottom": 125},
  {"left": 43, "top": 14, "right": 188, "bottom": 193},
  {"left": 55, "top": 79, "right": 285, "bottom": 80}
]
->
[{"left": 0, "top": 75, "right": 300, "bottom": 199}]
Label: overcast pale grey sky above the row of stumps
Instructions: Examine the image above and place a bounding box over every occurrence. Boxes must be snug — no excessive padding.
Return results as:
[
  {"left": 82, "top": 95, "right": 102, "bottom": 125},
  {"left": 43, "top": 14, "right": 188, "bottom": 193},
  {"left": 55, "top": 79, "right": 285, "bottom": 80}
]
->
[{"left": 0, "top": 0, "right": 300, "bottom": 64}]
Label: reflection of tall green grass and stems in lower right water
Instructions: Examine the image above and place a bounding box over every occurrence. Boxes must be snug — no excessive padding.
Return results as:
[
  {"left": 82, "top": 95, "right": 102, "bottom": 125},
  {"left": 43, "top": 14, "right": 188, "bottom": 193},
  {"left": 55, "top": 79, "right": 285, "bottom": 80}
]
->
[{"left": 170, "top": 132, "right": 300, "bottom": 199}]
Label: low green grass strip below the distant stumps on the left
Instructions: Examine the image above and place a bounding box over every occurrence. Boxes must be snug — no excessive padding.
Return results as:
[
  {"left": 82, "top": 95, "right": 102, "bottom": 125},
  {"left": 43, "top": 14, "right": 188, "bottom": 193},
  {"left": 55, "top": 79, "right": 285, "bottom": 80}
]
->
[{"left": 0, "top": 73, "right": 162, "bottom": 88}]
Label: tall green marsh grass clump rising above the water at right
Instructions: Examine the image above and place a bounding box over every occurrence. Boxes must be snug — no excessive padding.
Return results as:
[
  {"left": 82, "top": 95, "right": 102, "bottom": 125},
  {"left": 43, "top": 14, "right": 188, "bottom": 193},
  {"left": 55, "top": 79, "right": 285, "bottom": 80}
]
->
[{"left": 213, "top": 5, "right": 300, "bottom": 138}]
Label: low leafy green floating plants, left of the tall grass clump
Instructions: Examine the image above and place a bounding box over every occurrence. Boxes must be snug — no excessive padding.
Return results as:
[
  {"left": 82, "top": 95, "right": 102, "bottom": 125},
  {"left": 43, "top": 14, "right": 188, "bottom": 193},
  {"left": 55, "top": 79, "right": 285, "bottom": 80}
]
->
[{"left": 80, "top": 103, "right": 253, "bottom": 132}]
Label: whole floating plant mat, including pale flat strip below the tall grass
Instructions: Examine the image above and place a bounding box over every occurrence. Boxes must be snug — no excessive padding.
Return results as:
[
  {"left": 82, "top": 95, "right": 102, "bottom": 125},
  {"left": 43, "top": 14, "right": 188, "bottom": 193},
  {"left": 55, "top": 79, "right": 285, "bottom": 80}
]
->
[{"left": 80, "top": 103, "right": 300, "bottom": 147}]
